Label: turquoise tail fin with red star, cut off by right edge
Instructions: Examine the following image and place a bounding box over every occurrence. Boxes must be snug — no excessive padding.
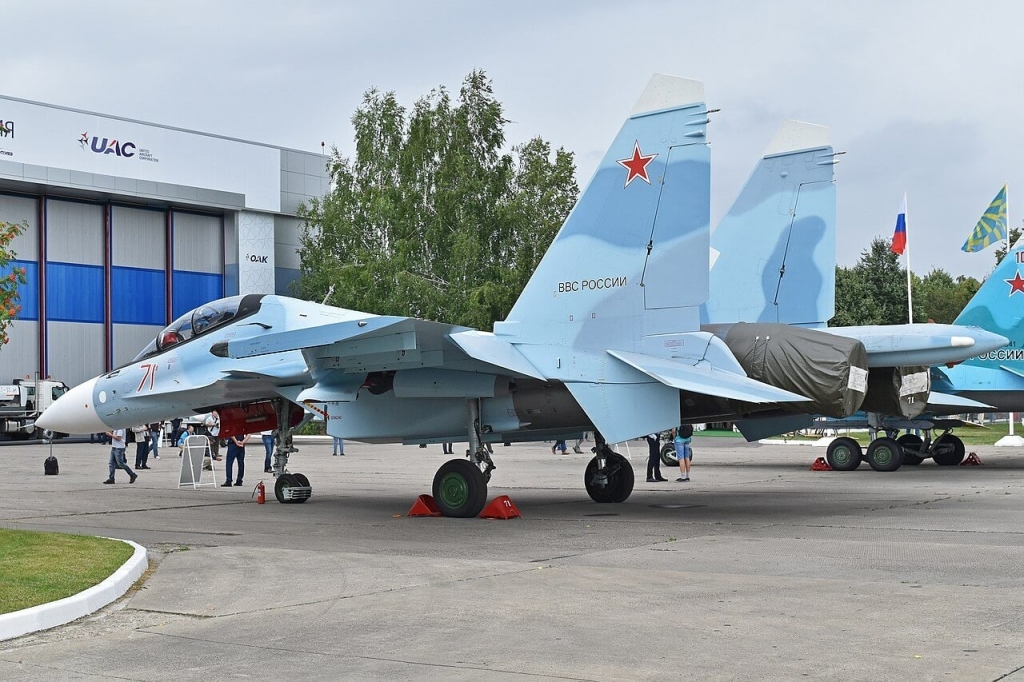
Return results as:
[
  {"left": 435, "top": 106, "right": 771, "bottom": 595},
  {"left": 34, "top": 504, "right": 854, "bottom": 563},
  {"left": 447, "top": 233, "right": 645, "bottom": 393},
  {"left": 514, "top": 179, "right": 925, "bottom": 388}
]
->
[{"left": 953, "top": 235, "right": 1024, "bottom": 377}]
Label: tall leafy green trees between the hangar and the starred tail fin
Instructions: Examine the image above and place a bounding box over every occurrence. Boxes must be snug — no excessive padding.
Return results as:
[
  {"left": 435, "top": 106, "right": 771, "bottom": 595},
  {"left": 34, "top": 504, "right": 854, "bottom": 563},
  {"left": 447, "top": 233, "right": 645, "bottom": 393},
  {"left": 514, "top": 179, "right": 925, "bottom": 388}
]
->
[{"left": 295, "top": 71, "right": 579, "bottom": 328}]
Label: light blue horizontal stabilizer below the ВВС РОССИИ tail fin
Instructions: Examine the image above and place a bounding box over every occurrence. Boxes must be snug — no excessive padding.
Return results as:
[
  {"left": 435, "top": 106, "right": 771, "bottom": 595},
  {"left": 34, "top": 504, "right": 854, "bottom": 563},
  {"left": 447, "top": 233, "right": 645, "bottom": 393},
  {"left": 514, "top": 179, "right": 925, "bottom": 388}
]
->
[{"left": 607, "top": 350, "right": 810, "bottom": 402}]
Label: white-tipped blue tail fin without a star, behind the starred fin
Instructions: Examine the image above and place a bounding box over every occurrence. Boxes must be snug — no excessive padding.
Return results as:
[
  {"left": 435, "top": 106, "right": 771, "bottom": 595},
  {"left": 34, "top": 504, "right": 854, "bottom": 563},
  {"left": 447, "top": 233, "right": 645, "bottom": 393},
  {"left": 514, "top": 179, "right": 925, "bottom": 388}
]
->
[{"left": 700, "top": 121, "right": 836, "bottom": 327}]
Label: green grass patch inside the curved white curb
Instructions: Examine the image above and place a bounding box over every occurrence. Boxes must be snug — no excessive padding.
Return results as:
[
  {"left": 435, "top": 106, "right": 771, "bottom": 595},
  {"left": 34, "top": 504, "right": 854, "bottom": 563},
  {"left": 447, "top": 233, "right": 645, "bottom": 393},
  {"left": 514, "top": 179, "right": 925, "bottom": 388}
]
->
[{"left": 0, "top": 528, "right": 134, "bottom": 613}]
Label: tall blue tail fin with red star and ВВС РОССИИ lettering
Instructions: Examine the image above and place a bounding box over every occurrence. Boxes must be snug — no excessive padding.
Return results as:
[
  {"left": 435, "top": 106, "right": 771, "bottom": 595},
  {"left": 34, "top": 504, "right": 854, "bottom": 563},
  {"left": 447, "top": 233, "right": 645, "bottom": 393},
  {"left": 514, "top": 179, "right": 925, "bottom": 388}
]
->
[{"left": 495, "top": 75, "right": 711, "bottom": 350}]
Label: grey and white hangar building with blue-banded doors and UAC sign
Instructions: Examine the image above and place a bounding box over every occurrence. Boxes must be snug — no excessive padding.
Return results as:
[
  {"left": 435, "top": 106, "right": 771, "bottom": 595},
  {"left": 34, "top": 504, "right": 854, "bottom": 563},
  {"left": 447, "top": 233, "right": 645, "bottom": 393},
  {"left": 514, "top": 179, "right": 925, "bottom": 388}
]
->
[{"left": 0, "top": 95, "right": 329, "bottom": 386}]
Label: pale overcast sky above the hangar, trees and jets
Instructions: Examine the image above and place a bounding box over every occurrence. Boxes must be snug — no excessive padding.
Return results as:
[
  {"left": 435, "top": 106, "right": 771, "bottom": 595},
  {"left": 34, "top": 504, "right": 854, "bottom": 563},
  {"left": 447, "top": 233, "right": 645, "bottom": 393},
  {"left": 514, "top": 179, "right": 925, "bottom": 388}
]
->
[{"left": 0, "top": 0, "right": 1024, "bottom": 279}]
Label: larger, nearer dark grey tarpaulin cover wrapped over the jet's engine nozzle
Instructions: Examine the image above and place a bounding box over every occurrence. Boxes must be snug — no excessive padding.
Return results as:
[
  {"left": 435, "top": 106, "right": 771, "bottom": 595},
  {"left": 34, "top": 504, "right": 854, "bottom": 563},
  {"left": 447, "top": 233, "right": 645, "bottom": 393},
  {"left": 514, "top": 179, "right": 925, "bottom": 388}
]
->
[{"left": 725, "top": 323, "right": 867, "bottom": 419}]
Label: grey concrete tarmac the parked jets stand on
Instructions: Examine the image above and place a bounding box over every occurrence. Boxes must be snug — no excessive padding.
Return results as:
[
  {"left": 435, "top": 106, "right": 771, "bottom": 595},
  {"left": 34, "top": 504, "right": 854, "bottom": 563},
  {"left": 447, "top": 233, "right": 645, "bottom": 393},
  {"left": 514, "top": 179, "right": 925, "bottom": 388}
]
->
[{"left": 0, "top": 437, "right": 1024, "bottom": 681}]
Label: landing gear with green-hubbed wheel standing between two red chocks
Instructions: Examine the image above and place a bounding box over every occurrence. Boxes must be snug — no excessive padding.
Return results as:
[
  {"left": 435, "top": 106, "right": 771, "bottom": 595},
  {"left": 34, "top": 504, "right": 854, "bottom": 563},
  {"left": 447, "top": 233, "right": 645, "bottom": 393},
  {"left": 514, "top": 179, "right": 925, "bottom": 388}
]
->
[{"left": 432, "top": 400, "right": 495, "bottom": 518}]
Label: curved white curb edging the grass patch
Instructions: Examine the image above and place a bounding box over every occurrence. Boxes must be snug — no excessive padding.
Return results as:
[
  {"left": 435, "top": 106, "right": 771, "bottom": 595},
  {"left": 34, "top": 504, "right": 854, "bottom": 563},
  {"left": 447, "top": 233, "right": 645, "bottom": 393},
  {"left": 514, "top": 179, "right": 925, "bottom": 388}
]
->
[{"left": 0, "top": 538, "right": 150, "bottom": 641}]
